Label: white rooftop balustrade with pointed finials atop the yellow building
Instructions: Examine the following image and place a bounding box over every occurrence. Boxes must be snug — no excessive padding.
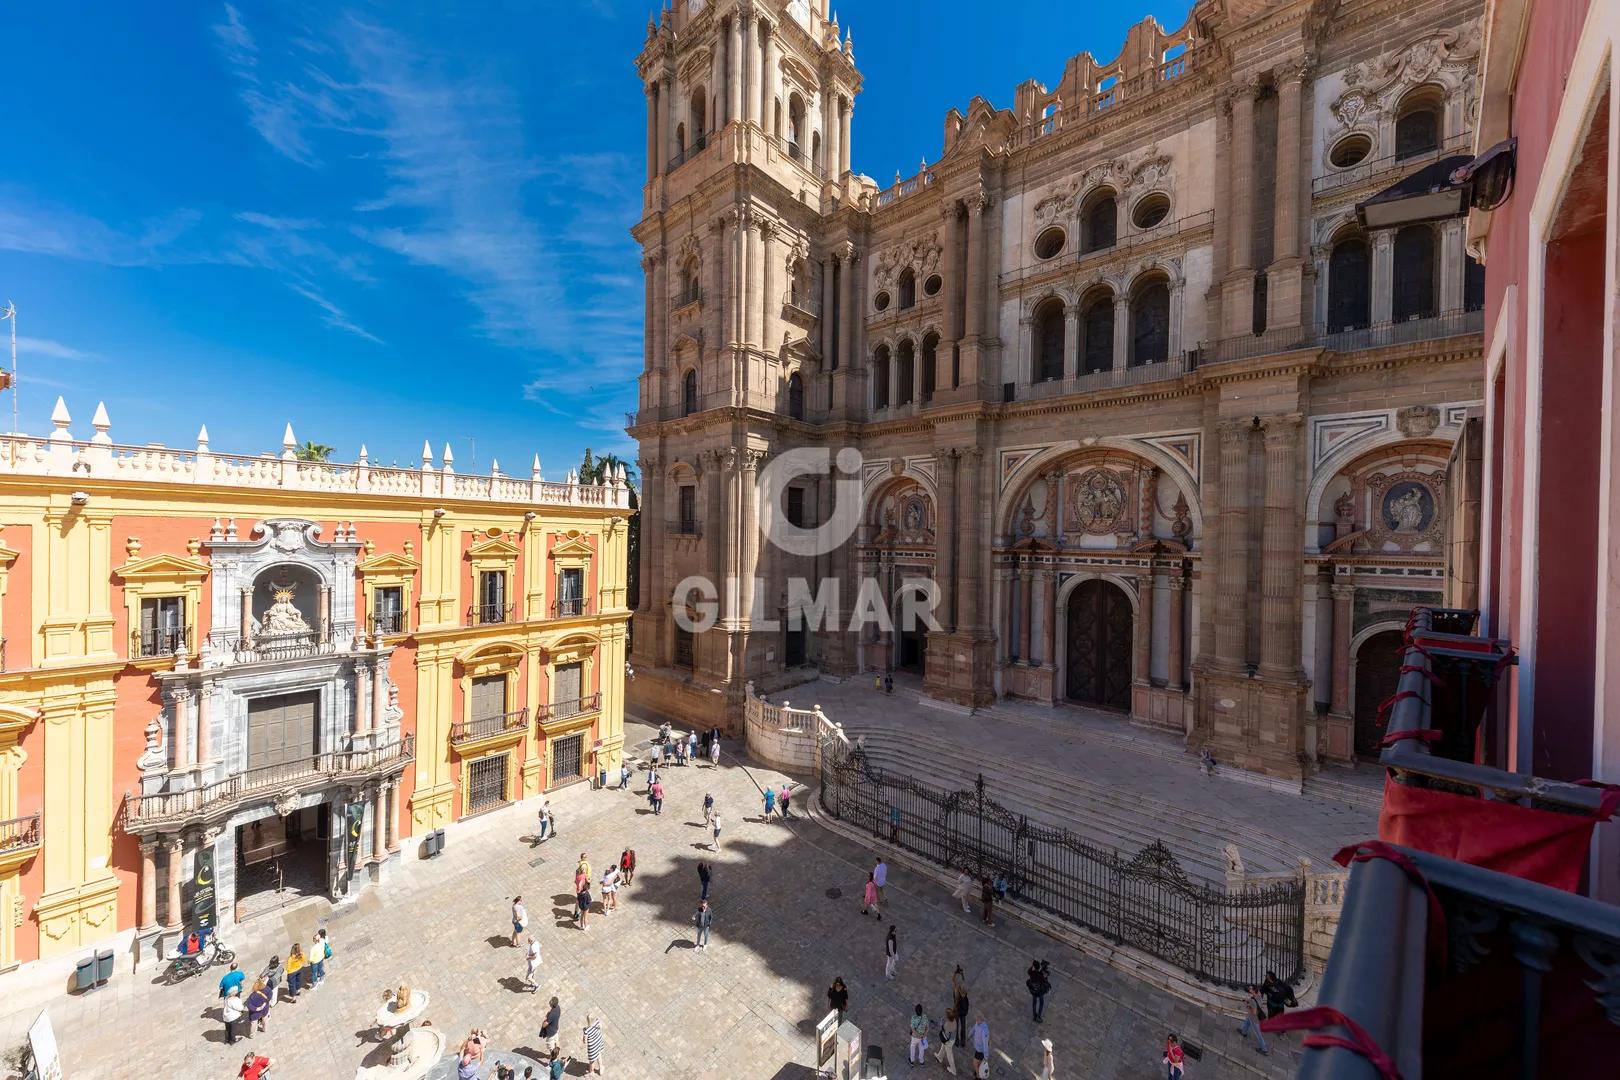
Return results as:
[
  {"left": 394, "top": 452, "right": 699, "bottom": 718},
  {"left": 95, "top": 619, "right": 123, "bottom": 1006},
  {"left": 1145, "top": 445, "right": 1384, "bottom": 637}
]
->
[{"left": 0, "top": 398, "right": 630, "bottom": 510}]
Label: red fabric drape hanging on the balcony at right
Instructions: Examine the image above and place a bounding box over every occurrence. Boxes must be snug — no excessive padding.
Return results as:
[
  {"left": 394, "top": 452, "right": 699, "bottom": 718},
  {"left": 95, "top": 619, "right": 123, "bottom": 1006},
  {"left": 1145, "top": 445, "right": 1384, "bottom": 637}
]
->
[{"left": 1379, "top": 777, "right": 1620, "bottom": 892}]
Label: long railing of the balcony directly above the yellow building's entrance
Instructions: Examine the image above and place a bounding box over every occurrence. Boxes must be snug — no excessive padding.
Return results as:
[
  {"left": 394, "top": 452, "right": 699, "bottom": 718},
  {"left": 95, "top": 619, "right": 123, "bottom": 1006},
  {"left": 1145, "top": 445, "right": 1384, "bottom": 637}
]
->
[{"left": 123, "top": 735, "right": 416, "bottom": 831}]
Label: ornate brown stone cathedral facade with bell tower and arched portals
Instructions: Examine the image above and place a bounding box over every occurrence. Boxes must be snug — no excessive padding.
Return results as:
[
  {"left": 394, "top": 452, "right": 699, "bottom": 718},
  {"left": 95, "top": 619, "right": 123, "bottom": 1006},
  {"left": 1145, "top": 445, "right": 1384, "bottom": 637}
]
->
[{"left": 629, "top": 0, "right": 1482, "bottom": 780}]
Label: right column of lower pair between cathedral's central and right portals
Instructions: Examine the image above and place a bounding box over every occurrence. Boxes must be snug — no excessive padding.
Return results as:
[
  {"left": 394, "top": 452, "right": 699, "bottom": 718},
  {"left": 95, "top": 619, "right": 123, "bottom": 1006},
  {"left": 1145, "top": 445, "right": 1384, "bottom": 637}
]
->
[{"left": 1260, "top": 415, "right": 1302, "bottom": 678}]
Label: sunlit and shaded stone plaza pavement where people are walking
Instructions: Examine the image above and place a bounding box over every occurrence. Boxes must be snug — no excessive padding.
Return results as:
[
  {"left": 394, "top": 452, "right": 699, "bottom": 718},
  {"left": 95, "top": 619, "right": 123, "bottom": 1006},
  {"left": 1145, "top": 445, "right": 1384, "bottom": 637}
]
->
[{"left": 0, "top": 721, "right": 1298, "bottom": 1080}]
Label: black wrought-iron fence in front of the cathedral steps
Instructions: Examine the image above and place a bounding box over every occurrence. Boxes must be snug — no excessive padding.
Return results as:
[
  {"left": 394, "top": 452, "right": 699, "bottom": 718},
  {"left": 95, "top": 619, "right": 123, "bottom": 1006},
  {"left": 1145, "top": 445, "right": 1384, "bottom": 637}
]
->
[{"left": 821, "top": 742, "right": 1306, "bottom": 988}]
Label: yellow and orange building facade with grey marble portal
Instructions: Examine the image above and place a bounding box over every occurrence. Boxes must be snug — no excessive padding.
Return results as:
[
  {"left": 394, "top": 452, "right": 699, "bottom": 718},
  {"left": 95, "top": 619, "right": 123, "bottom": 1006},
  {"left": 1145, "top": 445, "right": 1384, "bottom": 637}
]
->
[{"left": 0, "top": 402, "right": 630, "bottom": 975}]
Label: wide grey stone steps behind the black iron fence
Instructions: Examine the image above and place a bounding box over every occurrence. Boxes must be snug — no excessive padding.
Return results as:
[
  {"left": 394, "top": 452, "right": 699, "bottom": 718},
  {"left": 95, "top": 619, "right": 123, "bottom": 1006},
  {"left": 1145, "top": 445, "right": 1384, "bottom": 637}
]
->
[{"left": 846, "top": 727, "right": 1309, "bottom": 884}]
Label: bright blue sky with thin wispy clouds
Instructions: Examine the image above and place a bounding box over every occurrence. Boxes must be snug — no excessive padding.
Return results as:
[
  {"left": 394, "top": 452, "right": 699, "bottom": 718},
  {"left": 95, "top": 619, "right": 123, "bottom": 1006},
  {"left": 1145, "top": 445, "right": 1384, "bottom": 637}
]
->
[{"left": 0, "top": 0, "right": 1187, "bottom": 478}]
